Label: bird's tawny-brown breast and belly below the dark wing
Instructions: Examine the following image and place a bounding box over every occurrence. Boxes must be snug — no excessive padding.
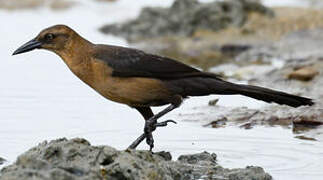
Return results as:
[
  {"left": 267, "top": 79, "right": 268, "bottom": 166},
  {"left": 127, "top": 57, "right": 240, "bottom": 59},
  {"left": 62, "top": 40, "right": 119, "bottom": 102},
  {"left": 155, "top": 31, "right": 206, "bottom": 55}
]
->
[{"left": 67, "top": 57, "right": 171, "bottom": 106}]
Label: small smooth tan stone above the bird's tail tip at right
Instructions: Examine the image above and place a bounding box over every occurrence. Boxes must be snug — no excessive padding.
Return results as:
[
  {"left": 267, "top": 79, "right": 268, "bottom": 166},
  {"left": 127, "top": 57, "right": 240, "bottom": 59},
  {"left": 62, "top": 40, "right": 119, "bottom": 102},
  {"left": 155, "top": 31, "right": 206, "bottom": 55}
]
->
[{"left": 288, "top": 67, "right": 319, "bottom": 81}]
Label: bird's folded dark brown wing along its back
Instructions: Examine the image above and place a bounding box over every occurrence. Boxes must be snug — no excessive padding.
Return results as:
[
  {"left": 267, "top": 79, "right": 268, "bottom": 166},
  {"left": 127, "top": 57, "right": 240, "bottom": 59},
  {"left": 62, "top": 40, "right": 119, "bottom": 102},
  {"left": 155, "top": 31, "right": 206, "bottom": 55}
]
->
[{"left": 94, "top": 45, "right": 218, "bottom": 79}]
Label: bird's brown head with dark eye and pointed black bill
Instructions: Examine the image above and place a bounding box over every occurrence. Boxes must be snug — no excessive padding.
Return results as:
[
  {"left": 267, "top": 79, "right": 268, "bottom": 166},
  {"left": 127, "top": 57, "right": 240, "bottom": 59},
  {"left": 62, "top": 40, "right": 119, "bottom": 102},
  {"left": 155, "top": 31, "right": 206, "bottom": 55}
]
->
[{"left": 13, "top": 25, "right": 77, "bottom": 55}]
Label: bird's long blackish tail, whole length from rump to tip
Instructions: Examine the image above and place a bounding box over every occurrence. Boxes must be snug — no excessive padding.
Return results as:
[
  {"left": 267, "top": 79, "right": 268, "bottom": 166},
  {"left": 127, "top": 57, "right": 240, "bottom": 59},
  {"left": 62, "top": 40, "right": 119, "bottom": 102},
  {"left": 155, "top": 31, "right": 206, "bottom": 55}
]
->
[{"left": 176, "top": 77, "right": 314, "bottom": 107}]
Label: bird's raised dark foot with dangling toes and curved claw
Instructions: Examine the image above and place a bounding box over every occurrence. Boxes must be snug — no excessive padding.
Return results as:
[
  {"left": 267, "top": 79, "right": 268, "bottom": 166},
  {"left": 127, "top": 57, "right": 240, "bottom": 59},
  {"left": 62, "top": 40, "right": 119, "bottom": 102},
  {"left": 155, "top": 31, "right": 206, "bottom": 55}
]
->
[{"left": 144, "top": 119, "right": 177, "bottom": 151}]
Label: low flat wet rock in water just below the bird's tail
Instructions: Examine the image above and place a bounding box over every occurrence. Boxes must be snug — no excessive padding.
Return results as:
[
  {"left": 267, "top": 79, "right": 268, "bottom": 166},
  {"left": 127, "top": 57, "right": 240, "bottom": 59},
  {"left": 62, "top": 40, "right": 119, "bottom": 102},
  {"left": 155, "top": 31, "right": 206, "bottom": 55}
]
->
[{"left": 208, "top": 100, "right": 323, "bottom": 132}]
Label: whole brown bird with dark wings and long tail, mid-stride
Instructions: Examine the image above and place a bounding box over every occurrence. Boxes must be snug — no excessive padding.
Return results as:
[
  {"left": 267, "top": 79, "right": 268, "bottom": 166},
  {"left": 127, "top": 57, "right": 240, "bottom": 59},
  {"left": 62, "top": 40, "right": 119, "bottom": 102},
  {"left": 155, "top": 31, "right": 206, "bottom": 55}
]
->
[{"left": 13, "top": 25, "right": 314, "bottom": 150}]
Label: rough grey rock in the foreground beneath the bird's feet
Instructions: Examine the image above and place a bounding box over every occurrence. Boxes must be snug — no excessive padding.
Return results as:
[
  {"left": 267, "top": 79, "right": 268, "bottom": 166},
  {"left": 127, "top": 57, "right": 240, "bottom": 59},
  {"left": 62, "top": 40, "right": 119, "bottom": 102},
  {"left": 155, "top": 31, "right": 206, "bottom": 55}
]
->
[{"left": 0, "top": 138, "right": 272, "bottom": 180}]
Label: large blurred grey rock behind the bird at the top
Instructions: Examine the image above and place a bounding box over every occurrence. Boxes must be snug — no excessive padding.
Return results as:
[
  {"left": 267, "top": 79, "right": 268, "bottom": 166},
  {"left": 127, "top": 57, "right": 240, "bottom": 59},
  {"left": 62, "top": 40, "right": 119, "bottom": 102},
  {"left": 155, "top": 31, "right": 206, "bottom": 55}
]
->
[{"left": 100, "top": 0, "right": 274, "bottom": 41}]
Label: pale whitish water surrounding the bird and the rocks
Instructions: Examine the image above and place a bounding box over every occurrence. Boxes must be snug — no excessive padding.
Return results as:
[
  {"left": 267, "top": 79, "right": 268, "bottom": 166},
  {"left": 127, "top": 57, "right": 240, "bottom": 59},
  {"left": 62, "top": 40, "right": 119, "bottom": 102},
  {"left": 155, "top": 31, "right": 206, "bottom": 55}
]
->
[{"left": 0, "top": 0, "right": 323, "bottom": 180}]
